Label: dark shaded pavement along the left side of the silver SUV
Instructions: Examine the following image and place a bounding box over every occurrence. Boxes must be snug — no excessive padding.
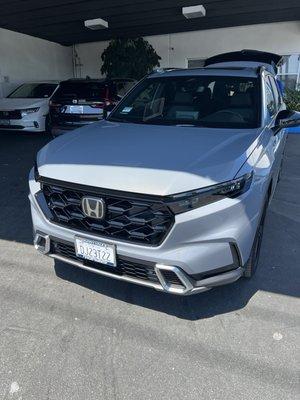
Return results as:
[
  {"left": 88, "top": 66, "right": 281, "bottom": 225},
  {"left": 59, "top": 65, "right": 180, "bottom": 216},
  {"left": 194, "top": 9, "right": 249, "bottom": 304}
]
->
[{"left": 0, "top": 132, "right": 50, "bottom": 244}]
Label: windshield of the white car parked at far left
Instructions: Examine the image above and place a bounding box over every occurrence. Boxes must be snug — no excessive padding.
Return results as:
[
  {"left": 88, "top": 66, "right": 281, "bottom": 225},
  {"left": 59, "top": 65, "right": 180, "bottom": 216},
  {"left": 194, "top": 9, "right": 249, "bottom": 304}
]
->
[{"left": 8, "top": 83, "right": 57, "bottom": 99}]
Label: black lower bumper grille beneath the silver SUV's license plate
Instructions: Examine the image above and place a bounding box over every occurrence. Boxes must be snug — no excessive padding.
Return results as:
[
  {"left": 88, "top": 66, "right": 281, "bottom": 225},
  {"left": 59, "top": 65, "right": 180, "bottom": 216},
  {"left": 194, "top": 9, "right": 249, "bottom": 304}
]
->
[{"left": 51, "top": 240, "right": 159, "bottom": 283}]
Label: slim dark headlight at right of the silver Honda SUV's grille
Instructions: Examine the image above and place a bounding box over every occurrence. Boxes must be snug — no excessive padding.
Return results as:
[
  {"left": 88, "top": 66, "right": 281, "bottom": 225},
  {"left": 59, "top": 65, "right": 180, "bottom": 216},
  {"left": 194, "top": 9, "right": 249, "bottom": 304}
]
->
[{"left": 167, "top": 172, "right": 253, "bottom": 214}]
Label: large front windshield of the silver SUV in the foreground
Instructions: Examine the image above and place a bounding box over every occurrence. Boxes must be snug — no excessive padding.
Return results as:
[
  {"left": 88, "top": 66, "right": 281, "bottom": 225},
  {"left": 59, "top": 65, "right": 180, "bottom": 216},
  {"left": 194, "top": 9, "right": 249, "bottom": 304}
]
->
[{"left": 108, "top": 76, "right": 260, "bottom": 128}]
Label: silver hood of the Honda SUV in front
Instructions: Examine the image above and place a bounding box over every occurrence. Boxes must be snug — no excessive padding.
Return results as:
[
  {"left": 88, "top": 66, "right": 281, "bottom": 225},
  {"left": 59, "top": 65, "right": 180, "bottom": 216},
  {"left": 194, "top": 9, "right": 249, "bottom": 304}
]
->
[{"left": 37, "top": 121, "right": 260, "bottom": 195}]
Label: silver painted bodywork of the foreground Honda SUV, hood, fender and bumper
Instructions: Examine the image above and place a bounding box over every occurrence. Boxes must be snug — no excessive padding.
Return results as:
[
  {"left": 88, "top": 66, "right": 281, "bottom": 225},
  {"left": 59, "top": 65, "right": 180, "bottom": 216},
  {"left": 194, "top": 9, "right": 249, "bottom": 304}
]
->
[{"left": 29, "top": 67, "right": 286, "bottom": 294}]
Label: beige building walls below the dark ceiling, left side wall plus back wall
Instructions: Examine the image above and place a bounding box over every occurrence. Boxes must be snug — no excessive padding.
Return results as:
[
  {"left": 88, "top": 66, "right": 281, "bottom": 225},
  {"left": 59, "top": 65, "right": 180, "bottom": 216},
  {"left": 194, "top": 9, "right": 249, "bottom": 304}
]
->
[{"left": 0, "top": 21, "right": 300, "bottom": 97}]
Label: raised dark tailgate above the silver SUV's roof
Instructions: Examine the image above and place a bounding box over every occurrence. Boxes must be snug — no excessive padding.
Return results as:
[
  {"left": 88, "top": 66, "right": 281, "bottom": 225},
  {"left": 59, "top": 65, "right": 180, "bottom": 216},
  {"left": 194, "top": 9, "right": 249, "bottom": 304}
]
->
[{"left": 204, "top": 50, "right": 284, "bottom": 74}]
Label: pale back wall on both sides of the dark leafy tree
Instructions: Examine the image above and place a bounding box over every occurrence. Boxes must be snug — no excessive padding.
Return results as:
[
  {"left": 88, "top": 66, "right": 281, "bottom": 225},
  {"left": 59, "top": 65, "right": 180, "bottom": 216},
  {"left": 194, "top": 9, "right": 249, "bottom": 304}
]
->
[{"left": 76, "top": 21, "right": 300, "bottom": 77}]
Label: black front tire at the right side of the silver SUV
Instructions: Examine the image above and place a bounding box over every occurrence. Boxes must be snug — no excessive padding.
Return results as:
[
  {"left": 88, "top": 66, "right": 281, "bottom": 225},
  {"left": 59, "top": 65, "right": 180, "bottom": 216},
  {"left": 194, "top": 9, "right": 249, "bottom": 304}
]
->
[{"left": 244, "top": 196, "right": 269, "bottom": 279}]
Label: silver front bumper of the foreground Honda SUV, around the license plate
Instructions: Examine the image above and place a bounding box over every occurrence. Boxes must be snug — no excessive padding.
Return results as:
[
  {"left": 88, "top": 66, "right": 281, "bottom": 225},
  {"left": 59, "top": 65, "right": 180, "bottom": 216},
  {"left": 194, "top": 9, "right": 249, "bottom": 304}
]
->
[{"left": 29, "top": 167, "right": 264, "bottom": 294}]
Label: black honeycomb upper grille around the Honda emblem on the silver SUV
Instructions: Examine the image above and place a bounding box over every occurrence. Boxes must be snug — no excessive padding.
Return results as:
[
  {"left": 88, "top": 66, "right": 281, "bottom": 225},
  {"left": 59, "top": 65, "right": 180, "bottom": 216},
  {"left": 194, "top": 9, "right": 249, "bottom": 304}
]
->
[{"left": 41, "top": 178, "right": 174, "bottom": 246}]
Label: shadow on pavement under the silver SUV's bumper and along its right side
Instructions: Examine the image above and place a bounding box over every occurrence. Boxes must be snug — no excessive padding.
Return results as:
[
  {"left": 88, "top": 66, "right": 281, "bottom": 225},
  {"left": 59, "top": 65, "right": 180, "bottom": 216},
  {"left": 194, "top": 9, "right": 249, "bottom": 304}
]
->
[{"left": 55, "top": 135, "right": 300, "bottom": 320}]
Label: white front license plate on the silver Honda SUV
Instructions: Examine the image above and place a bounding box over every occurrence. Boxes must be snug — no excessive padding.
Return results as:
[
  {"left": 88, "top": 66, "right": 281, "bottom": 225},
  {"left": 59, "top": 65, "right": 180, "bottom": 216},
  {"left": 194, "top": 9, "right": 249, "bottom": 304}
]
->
[{"left": 75, "top": 237, "right": 117, "bottom": 267}]
